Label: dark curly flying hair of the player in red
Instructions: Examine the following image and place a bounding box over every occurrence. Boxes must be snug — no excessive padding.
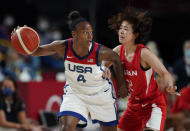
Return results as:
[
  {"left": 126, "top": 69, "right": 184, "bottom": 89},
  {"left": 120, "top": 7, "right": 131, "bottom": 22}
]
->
[{"left": 108, "top": 7, "right": 152, "bottom": 43}]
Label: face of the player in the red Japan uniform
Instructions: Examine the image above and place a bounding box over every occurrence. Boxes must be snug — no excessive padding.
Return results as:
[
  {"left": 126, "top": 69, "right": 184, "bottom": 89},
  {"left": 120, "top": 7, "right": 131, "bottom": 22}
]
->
[{"left": 118, "top": 21, "right": 136, "bottom": 43}]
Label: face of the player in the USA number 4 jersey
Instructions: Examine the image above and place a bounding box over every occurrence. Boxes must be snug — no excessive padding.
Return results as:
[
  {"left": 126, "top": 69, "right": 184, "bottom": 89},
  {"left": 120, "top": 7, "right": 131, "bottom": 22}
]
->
[{"left": 73, "top": 22, "right": 93, "bottom": 43}]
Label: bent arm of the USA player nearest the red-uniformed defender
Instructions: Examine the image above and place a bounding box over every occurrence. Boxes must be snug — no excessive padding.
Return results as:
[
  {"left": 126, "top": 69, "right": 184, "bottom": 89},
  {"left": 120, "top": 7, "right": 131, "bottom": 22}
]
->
[{"left": 98, "top": 46, "right": 128, "bottom": 97}]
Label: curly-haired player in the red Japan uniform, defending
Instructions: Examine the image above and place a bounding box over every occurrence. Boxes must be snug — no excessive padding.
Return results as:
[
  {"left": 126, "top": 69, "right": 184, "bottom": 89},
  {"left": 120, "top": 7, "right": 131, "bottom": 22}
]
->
[{"left": 105, "top": 8, "right": 177, "bottom": 131}]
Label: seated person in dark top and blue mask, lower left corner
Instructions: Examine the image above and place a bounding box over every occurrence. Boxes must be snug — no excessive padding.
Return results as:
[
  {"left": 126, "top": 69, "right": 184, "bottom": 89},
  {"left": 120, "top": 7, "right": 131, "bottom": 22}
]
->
[{"left": 0, "top": 77, "right": 42, "bottom": 131}]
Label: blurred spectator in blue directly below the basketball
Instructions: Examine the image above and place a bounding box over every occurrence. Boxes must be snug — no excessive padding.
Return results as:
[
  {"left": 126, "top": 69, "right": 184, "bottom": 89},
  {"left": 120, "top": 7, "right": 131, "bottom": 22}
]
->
[{"left": 5, "top": 49, "right": 41, "bottom": 81}]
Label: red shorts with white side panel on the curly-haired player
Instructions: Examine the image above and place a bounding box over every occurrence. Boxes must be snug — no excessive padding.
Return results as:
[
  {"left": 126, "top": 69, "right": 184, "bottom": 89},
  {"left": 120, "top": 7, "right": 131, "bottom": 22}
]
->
[{"left": 118, "top": 103, "right": 166, "bottom": 131}]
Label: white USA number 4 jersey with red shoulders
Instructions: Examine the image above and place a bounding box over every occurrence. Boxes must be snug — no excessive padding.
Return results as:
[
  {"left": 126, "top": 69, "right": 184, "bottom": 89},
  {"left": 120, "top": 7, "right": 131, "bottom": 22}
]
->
[{"left": 64, "top": 39, "right": 111, "bottom": 95}]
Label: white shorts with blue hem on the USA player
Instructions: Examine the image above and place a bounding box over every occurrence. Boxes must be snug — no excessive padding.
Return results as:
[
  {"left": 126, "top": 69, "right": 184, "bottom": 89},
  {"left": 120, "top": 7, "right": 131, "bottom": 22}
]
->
[{"left": 57, "top": 83, "right": 118, "bottom": 127}]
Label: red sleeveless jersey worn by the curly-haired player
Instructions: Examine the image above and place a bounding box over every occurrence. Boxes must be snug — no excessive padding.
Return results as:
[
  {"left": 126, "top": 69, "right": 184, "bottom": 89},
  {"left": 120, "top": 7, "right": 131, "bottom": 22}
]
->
[{"left": 120, "top": 44, "right": 161, "bottom": 104}]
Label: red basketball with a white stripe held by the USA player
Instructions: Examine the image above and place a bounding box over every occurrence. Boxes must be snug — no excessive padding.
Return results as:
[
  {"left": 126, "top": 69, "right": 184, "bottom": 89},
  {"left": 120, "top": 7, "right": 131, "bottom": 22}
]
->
[{"left": 11, "top": 26, "right": 40, "bottom": 55}]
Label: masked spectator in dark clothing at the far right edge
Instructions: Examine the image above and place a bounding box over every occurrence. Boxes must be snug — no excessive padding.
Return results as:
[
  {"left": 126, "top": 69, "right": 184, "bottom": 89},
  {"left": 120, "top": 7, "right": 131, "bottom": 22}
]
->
[{"left": 174, "top": 40, "right": 190, "bottom": 90}]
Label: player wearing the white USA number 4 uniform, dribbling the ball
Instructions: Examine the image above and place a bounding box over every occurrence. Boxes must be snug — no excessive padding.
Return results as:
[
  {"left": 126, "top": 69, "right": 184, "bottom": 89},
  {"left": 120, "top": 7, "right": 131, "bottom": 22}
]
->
[{"left": 13, "top": 11, "right": 128, "bottom": 131}]
